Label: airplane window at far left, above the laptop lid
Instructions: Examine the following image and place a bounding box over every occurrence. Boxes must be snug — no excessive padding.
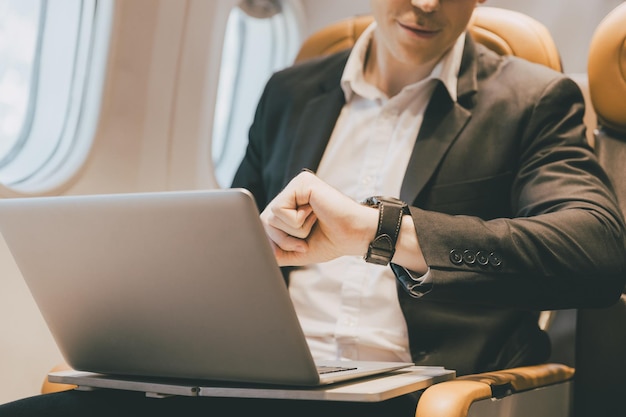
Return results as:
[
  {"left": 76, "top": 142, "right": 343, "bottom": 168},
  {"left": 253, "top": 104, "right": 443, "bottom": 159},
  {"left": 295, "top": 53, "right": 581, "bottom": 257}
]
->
[{"left": 0, "top": 0, "right": 113, "bottom": 193}]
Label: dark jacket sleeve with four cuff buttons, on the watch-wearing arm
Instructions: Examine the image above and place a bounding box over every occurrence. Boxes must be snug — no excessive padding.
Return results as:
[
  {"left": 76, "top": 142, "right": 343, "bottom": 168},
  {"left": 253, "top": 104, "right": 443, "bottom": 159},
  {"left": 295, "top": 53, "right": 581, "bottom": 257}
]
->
[{"left": 392, "top": 78, "right": 626, "bottom": 310}]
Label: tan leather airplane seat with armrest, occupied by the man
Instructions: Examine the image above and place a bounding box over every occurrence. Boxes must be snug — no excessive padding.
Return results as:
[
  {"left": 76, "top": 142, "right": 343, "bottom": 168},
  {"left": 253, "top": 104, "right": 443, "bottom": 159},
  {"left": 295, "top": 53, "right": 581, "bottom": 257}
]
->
[{"left": 42, "top": 7, "right": 574, "bottom": 417}]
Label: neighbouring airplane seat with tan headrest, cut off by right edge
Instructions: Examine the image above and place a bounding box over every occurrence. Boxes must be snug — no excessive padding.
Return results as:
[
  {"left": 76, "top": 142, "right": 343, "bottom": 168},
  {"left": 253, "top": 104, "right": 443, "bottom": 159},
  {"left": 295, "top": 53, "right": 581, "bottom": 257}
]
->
[{"left": 574, "top": 3, "right": 626, "bottom": 417}]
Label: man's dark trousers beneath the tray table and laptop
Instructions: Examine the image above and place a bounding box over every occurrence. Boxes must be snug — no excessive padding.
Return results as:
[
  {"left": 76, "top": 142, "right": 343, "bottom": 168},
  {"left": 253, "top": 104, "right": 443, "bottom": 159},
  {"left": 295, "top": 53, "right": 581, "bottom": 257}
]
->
[{"left": 0, "top": 389, "right": 419, "bottom": 417}]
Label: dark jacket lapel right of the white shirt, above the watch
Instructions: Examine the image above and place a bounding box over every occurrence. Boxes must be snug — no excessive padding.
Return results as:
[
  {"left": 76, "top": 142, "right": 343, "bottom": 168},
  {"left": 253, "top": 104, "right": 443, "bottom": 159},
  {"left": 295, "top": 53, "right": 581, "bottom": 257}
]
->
[{"left": 400, "top": 34, "right": 477, "bottom": 202}]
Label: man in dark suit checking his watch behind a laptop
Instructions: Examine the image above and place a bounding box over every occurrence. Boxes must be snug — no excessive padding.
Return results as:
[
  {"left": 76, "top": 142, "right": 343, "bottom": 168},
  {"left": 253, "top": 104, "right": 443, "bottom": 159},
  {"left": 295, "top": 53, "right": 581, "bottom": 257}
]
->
[{"left": 0, "top": 0, "right": 626, "bottom": 416}]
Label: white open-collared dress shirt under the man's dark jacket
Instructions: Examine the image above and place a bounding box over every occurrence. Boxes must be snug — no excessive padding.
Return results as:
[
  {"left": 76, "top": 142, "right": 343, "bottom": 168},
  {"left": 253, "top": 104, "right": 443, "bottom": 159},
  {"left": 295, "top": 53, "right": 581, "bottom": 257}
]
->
[{"left": 289, "top": 23, "right": 465, "bottom": 362}]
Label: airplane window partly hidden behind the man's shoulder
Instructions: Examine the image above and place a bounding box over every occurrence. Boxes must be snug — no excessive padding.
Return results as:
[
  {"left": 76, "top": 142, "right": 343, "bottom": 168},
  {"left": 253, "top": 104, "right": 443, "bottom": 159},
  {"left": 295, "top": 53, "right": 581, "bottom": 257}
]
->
[{"left": 212, "top": 0, "right": 303, "bottom": 187}]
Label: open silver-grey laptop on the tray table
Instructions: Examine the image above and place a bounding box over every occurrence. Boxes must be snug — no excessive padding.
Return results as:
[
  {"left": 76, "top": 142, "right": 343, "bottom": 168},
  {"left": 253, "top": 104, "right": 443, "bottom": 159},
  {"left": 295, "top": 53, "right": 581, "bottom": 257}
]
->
[{"left": 0, "top": 189, "right": 413, "bottom": 386}]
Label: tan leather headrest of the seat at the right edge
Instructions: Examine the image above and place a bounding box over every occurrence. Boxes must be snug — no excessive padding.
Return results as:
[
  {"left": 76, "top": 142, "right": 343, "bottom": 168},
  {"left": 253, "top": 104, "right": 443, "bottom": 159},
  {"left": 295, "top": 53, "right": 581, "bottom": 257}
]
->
[{"left": 587, "top": 3, "right": 626, "bottom": 134}]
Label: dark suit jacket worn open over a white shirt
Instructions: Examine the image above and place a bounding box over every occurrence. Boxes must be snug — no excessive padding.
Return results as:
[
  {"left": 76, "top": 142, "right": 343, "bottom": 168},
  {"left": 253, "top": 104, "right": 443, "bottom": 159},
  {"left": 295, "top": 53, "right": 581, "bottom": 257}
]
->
[{"left": 232, "top": 36, "right": 626, "bottom": 375}]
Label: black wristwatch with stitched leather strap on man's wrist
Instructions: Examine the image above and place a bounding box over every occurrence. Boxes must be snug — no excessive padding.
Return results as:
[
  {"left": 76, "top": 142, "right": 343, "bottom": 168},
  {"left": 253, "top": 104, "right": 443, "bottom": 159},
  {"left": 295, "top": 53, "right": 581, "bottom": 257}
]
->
[{"left": 362, "top": 196, "right": 409, "bottom": 265}]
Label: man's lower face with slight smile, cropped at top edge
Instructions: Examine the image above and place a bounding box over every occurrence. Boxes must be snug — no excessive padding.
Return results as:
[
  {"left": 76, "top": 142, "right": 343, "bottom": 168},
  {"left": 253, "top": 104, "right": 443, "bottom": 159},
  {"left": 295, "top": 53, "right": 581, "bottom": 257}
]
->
[{"left": 371, "top": 0, "right": 485, "bottom": 65}]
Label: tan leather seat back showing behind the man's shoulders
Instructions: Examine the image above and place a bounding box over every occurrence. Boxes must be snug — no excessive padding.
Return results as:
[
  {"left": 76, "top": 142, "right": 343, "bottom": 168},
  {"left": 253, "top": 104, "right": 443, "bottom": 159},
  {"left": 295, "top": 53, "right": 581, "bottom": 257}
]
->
[{"left": 296, "top": 6, "right": 562, "bottom": 71}]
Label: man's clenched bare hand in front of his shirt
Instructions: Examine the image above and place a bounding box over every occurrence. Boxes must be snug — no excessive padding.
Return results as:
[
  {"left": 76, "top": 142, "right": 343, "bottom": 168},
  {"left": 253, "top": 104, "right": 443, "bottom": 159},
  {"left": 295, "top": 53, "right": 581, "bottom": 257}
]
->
[{"left": 261, "top": 172, "right": 378, "bottom": 266}]
